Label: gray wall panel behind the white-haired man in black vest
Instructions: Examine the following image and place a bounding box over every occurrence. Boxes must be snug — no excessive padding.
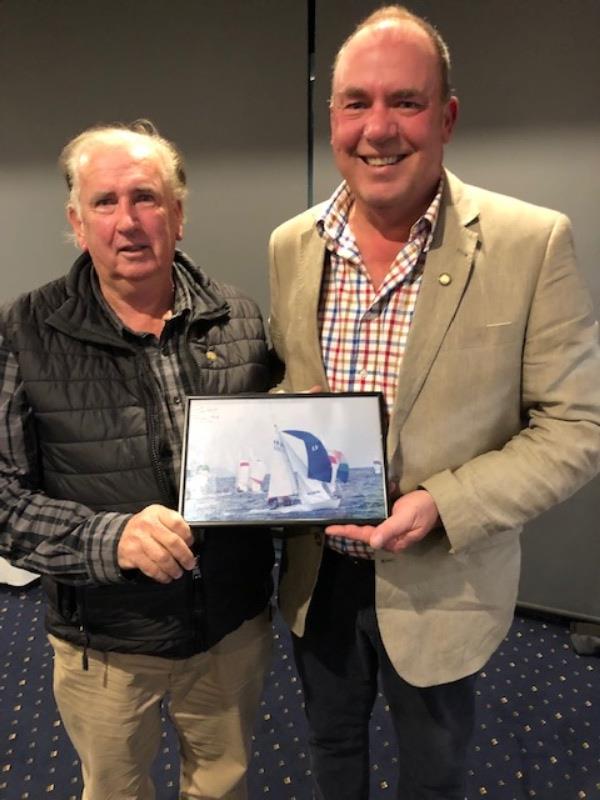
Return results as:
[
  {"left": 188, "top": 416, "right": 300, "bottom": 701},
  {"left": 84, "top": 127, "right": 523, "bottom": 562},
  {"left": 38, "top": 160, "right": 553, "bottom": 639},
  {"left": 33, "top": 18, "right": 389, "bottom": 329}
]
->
[{"left": 0, "top": 0, "right": 307, "bottom": 310}]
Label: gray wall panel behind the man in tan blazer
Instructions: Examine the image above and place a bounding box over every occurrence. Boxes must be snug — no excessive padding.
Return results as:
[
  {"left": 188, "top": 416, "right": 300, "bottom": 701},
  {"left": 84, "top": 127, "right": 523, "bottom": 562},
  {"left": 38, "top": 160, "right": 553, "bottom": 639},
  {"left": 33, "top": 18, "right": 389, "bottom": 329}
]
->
[{"left": 315, "top": 0, "right": 600, "bottom": 619}]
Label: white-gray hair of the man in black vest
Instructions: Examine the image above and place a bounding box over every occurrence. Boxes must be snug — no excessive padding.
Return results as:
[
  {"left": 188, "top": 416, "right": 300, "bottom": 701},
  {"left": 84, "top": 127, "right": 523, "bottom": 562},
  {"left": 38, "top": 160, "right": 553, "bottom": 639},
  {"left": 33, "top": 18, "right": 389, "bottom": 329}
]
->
[{"left": 58, "top": 119, "right": 187, "bottom": 213}]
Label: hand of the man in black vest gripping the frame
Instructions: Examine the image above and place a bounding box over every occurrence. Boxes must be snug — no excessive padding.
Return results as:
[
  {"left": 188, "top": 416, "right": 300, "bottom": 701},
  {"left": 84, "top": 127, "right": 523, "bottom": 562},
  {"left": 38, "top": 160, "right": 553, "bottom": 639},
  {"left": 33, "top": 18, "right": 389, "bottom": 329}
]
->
[{"left": 117, "top": 505, "right": 196, "bottom": 583}]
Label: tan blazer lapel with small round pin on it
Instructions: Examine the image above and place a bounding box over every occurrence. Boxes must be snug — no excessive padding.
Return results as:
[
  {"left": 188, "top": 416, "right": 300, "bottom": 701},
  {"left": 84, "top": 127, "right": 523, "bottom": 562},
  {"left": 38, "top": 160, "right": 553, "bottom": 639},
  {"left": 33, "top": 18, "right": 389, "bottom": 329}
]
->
[{"left": 389, "top": 173, "right": 479, "bottom": 440}]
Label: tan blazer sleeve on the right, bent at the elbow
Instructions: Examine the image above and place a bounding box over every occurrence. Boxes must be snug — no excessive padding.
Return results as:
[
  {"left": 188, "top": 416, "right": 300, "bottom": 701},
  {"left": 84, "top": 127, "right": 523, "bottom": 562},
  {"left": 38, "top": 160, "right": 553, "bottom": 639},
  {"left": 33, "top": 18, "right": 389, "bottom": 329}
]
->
[{"left": 421, "top": 215, "right": 600, "bottom": 551}]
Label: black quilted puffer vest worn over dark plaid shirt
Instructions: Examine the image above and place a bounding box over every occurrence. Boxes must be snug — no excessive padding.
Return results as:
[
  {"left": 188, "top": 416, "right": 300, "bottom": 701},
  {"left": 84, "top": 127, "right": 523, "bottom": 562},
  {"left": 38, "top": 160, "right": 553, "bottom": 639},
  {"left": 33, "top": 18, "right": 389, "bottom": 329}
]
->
[{"left": 6, "top": 253, "right": 273, "bottom": 658}]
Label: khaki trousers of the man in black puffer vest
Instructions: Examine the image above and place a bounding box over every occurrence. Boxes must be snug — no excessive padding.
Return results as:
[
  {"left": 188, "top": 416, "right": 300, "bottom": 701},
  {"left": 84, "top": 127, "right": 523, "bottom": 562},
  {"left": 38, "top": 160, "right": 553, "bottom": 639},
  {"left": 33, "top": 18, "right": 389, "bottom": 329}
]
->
[{"left": 49, "top": 611, "right": 272, "bottom": 800}]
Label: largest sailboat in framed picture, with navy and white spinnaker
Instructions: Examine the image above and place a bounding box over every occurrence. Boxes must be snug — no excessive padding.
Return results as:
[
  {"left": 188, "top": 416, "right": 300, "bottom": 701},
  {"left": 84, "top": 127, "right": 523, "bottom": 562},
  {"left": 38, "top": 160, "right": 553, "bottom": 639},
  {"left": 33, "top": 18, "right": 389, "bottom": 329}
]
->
[{"left": 267, "top": 426, "right": 340, "bottom": 512}]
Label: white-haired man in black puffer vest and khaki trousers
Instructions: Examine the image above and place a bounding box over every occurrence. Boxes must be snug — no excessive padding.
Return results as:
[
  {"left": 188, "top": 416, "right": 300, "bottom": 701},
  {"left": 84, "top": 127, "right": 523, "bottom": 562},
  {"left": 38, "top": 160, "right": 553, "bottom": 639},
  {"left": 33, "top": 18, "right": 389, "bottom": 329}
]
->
[{"left": 0, "top": 121, "right": 273, "bottom": 800}]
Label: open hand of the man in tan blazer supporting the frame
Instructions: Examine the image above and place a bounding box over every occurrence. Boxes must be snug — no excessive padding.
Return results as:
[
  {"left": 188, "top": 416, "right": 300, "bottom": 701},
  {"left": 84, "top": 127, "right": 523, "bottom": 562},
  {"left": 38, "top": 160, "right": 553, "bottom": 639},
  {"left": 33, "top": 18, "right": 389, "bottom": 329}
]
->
[{"left": 325, "top": 489, "right": 440, "bottom": 553}]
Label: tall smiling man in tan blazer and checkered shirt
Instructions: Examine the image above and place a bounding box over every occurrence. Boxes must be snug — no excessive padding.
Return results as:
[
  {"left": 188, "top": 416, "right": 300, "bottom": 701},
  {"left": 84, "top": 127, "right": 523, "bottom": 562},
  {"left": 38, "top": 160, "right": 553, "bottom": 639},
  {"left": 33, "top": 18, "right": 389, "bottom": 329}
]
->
[{"left": 270, "top": 6, "right": 600, "bottom": 800}]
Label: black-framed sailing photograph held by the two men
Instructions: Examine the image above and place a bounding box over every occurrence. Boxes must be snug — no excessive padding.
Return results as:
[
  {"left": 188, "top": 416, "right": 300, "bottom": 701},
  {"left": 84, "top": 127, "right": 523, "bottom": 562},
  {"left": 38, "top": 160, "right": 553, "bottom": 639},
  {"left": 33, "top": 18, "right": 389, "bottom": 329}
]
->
[{"left": 179, "top": 392, "right": 388, "bottom": 528}]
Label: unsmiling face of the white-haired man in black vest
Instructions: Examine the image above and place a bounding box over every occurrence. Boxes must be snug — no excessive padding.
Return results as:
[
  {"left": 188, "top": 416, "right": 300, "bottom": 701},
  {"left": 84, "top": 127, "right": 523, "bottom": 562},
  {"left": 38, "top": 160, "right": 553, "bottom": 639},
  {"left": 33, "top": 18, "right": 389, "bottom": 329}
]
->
[{"left": 69, "top": 143, "right": 183, "bottom": 292}]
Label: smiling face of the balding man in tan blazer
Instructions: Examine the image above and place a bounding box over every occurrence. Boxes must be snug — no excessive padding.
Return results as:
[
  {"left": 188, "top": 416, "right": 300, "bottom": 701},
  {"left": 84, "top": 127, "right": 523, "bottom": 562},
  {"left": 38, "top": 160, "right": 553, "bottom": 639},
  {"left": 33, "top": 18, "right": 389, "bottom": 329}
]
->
[{"left": 331, "top": 22, "right": 458, "bottom": 225}]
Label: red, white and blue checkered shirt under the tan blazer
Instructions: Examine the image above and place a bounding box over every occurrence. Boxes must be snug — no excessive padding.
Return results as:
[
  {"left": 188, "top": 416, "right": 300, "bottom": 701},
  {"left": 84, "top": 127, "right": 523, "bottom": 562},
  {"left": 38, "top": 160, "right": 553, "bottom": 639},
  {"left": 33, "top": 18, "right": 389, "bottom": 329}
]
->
[{"left": 317, "top": 181, "right": 443, "bottom": 558}]
